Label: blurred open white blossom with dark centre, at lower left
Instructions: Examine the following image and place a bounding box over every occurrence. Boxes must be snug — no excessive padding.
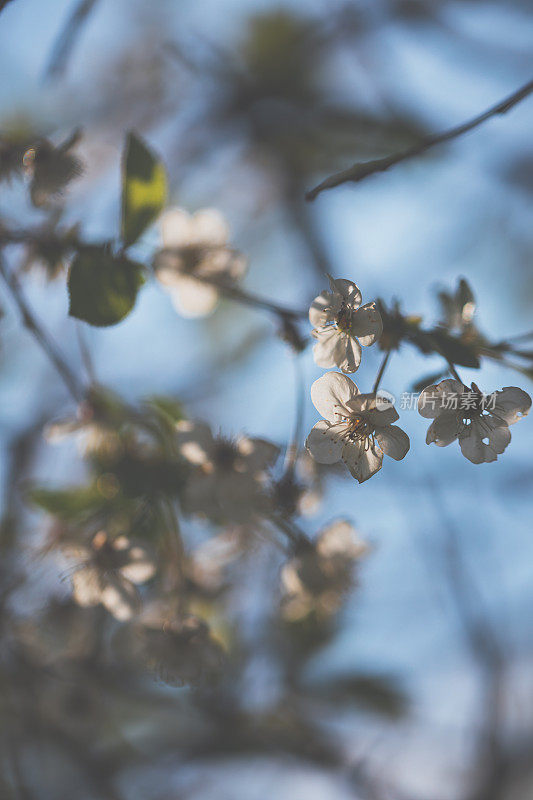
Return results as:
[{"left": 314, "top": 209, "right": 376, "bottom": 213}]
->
[{"left": 63, "top": 531, "right": 155, "bottom": 621}]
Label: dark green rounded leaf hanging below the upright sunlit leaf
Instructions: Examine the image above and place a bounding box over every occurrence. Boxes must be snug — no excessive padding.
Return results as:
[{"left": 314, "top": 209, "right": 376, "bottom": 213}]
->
[{"left": 68, "top": 245, "right": 144, "bottom": 326}]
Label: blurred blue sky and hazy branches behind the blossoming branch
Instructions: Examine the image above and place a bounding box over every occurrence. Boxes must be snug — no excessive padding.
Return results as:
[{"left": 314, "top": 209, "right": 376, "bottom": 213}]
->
[{"left": 0, "top": 0, "right": 533, "bottom": 800}]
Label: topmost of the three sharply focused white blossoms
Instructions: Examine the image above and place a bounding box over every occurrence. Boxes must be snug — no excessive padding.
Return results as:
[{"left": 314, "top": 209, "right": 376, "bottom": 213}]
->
[{"left": 309, "top": 277, "right": 383, "bottom": 372}]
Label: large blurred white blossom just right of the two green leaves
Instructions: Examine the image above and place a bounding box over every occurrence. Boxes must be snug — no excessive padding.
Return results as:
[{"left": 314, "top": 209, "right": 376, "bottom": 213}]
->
[{"left": 155, "top": 208, "right": 246, "bottom": 317}]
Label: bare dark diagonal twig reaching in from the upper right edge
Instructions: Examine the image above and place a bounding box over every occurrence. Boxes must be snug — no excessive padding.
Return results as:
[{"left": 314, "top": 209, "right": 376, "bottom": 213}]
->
[{"left": 306, "top": 80, "right": 533, "bottom": 200}]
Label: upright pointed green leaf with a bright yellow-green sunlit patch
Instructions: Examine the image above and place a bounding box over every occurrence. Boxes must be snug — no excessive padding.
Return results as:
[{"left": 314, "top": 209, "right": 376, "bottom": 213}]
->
[{"left": 122, "top": 133, "right": 167, "bottom": 247}]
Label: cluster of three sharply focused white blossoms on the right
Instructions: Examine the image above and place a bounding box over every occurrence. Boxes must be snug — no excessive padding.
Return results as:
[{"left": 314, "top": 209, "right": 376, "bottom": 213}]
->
[{"left": 306, "top": 278, "right": 531, "bottom": 476}]
